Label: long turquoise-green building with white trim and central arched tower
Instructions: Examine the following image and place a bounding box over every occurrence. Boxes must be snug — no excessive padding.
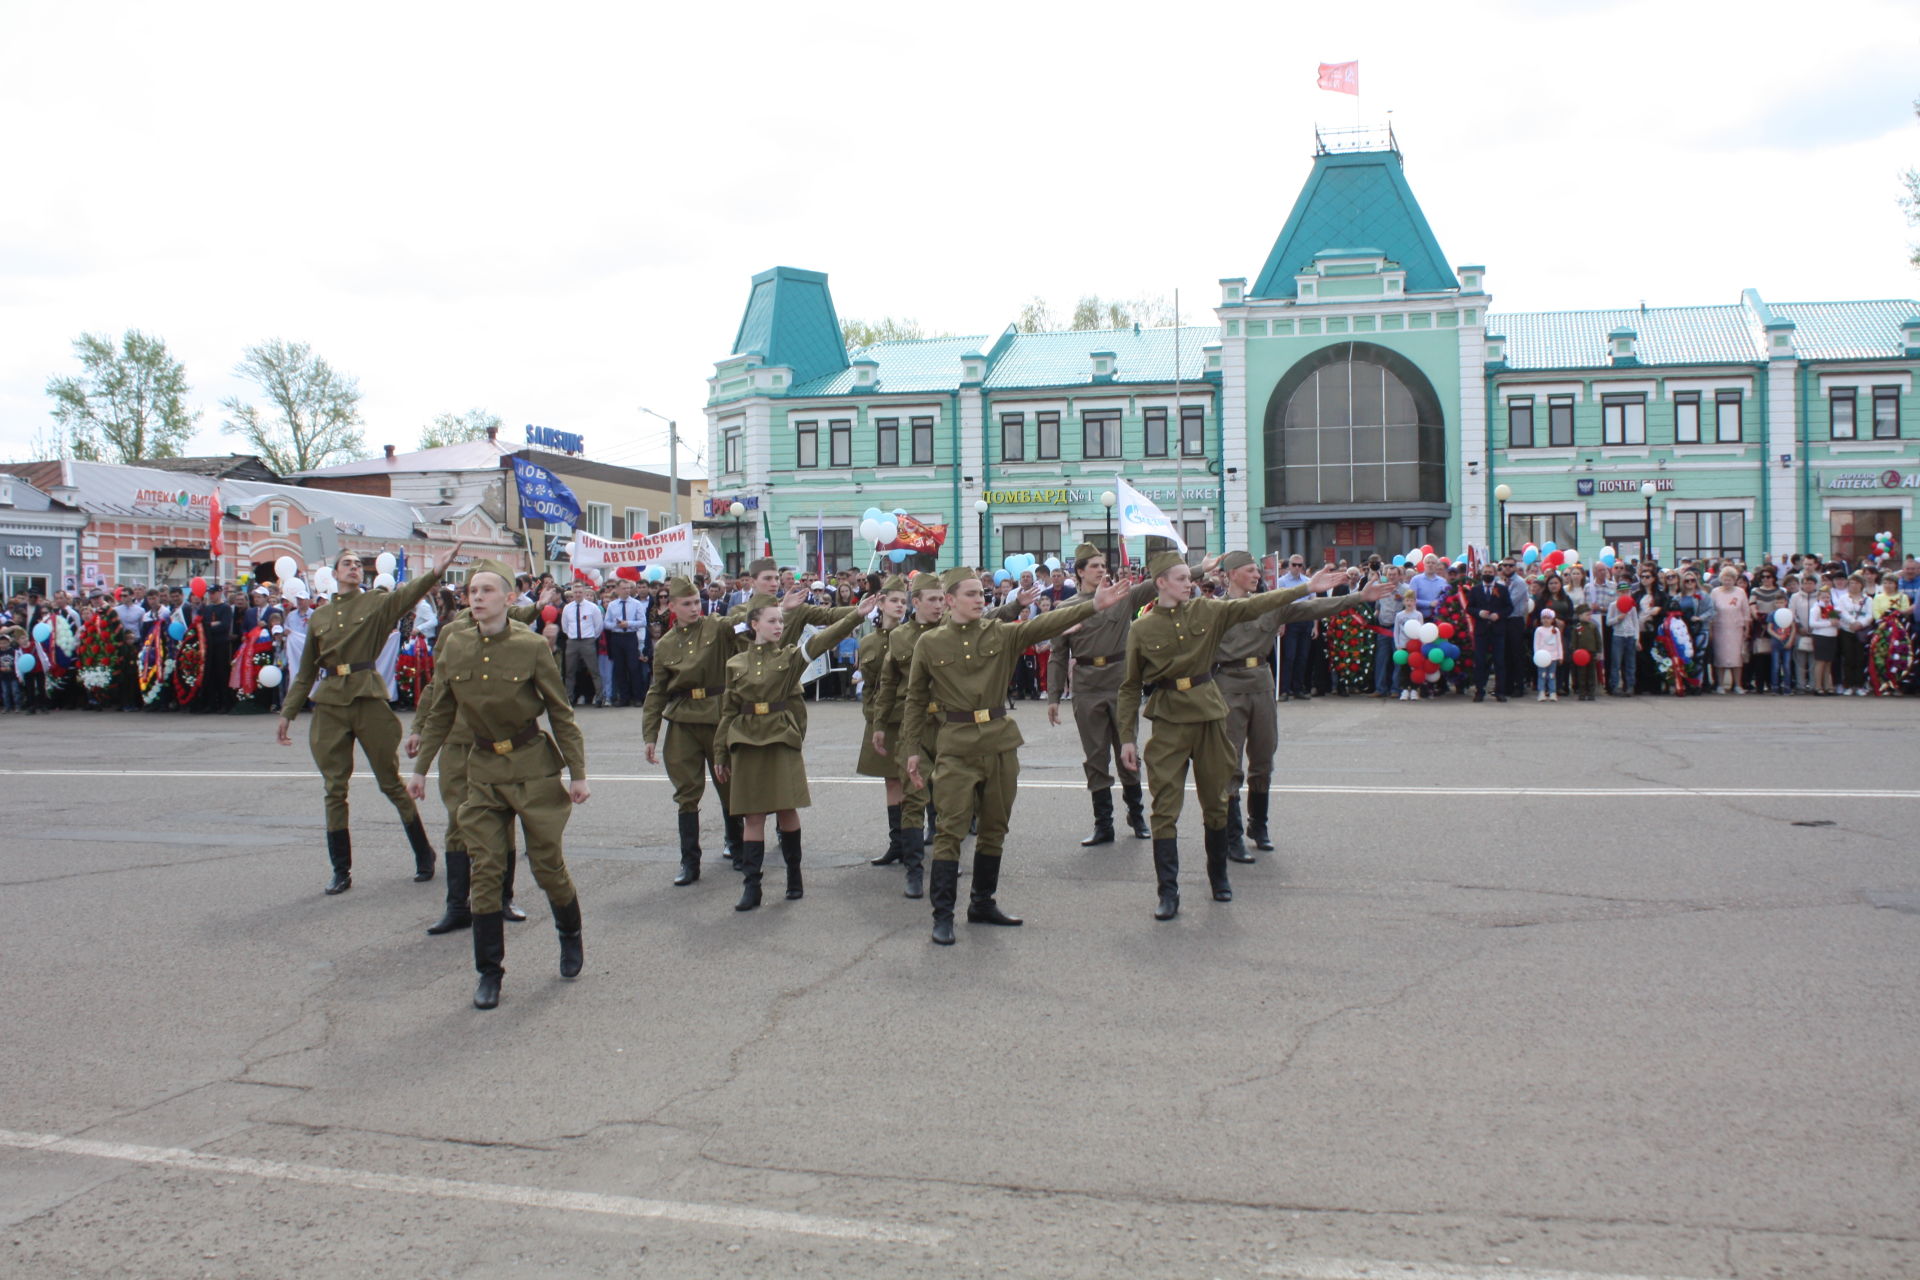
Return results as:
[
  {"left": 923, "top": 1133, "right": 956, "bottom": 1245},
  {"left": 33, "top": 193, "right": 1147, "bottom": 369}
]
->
[{"left": 707, "top": 136, "right": 1920, "bottom": 568}]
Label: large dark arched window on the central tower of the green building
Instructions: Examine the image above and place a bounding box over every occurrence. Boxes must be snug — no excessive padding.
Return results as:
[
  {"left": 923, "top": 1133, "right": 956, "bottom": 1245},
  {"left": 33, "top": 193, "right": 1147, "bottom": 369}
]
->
[{"left": 1267, "top": 351, "right": 1446, "bottom": 507}]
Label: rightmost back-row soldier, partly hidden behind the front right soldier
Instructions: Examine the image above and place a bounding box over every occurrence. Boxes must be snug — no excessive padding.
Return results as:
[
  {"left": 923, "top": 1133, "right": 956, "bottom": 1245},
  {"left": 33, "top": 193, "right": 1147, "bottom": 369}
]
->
[{"left": 1213, "top": 551, "right": 1354, "bottom": 862}]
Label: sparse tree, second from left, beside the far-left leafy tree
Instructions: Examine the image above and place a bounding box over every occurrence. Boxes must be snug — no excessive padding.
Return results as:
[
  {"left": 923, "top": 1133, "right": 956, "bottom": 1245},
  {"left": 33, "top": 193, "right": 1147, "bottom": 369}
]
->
[{"left": 221, "top": 338, "right": 367, "bottom": 476}]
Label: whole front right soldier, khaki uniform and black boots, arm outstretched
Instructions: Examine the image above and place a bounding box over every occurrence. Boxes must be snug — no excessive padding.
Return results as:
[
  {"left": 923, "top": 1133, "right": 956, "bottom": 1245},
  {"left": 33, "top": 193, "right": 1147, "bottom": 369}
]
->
[{"left": 1119, "top": 551, "right": 1386, "bottom": 919}]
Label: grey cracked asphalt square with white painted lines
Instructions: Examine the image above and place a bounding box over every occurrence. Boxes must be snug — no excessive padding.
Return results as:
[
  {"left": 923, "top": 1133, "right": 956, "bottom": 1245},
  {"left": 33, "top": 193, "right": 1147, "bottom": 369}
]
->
[{"left": 0, "top": 697, "right": 1920, "bottom": 1280}]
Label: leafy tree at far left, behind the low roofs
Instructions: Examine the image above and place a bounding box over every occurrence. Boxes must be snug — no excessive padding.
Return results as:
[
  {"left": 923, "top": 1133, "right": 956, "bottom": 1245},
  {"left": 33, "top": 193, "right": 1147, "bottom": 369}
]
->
[{"left": 46, "top": 328, "right": 200, "bottom": 462}]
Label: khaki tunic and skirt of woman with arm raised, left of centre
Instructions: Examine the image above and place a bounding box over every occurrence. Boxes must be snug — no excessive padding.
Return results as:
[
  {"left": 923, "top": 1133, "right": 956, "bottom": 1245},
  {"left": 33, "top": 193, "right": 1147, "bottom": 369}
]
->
[{"left": 714, "top": 610, "right": 860, "bottom": 818}]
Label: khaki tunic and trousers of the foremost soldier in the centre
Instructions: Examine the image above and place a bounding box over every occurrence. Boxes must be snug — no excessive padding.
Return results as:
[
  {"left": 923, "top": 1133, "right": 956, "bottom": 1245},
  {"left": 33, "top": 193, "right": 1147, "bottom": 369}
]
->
[{"left": 897, "top": 601, "right": 1092, "bottom": 862}]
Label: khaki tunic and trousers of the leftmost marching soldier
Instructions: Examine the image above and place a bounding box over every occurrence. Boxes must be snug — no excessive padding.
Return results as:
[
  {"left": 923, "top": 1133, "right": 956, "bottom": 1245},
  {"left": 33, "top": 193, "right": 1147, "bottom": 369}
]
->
[{"left": 280, "top": 570, "right": 440, "bottom": 831}]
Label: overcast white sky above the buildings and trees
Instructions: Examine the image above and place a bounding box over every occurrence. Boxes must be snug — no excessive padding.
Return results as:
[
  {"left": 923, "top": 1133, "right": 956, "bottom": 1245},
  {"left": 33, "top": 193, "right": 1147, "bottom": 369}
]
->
[{"left": 0, "top": 0, "right": 1920, "bottom": 474}]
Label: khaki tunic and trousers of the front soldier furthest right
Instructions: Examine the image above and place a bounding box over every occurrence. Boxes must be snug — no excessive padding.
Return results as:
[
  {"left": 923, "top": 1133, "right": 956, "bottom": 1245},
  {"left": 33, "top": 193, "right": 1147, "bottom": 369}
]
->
[{"left": 1119, "top": 587, "right": 1306, "bottom": 841}]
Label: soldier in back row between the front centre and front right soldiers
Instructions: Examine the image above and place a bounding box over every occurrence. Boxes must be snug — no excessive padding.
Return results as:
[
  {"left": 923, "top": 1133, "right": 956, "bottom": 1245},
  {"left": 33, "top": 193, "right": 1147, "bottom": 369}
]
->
[{"left": 1046, "top": 543, "right": 1154, "bottom": 844}]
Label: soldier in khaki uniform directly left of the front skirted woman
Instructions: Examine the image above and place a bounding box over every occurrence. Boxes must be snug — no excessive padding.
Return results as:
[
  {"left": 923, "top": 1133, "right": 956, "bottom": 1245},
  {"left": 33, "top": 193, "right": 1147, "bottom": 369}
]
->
[{"left": 639, "top": 578, "right": 739, "bottom": 885}]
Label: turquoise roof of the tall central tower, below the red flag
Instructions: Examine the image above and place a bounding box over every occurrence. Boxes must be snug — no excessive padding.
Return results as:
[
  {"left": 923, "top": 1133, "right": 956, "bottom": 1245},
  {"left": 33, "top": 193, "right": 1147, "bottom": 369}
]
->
[{"left": 1252, "top": 152, "right": 1459, "bottom": 297}]
